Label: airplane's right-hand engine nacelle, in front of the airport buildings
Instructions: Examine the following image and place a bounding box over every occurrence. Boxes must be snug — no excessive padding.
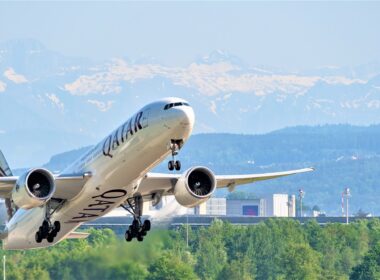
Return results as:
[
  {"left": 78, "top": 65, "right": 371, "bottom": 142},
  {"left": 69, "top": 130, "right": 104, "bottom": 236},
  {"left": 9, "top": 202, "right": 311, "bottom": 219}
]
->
[{"left": 174, "top": 167, "right": 216, "bottom": 207}]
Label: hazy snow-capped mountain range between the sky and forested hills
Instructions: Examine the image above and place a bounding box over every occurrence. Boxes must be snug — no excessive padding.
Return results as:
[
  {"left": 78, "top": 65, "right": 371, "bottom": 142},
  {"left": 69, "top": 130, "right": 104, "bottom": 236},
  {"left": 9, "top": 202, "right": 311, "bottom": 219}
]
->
[{"left": 0, "top": 39, "right": 380, "bottom": 167}]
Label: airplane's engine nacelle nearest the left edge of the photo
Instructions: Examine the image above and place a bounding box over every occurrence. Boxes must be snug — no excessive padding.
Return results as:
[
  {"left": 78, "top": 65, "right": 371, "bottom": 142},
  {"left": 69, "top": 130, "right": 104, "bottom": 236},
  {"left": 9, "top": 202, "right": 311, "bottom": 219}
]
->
[{"left": 12, "top": 168, "right": 55, "bottom": 209}]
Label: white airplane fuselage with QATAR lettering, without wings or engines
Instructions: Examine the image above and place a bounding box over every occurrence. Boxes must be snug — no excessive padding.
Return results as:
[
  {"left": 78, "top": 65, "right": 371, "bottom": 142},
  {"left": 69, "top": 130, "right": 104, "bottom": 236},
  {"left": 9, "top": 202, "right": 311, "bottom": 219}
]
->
[{"left": 3, "top": 98, "right": 194, "bottom": 249}]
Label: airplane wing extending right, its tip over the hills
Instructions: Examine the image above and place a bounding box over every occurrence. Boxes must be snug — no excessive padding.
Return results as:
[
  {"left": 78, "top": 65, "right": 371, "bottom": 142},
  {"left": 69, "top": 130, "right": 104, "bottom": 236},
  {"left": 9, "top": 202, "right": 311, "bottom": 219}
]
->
[{"left": 139, "top": 168, "right": 314, "bottom": 196}]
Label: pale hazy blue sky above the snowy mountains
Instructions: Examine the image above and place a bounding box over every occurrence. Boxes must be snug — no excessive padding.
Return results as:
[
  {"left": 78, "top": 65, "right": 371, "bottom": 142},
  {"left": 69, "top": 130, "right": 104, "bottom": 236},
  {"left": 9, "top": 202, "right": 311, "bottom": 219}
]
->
[{"left": 0, "top": 1, "right": 380, "bottom": 69}]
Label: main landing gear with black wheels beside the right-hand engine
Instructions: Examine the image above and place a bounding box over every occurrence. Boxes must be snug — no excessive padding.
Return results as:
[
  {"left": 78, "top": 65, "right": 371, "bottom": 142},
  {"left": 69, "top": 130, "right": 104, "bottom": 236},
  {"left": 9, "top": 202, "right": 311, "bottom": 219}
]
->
[{"left": 121, "top": 196, "right": 150, "bottom": 242}]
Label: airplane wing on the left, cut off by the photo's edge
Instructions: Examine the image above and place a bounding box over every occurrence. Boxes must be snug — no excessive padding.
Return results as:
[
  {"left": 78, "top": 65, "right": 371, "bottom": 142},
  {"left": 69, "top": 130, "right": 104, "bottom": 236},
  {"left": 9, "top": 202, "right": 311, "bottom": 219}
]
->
[{"left": 0, "top": 173, "right": 91, "bottom": 199}]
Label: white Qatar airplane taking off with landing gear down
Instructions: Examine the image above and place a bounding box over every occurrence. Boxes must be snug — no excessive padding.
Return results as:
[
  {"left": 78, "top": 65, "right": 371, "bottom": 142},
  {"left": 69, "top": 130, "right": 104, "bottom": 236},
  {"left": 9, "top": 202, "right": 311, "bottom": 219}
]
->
[{"left": 0, "top": 97, "right": 313, "bottom": 250}]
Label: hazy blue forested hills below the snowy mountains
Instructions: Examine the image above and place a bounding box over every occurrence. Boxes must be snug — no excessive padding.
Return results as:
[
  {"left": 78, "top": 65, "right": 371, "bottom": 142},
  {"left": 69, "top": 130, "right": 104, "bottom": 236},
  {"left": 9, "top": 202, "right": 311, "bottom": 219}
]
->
[{"left": 15, "top": 125, "right": 380, "bottom": 215}]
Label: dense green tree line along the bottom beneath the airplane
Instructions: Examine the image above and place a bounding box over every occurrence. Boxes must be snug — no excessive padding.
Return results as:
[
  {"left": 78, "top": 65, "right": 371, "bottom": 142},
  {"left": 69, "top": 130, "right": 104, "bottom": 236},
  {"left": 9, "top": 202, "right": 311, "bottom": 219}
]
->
[{"left": 1, "top": 218, "right": 380, "bottom": 280}]
